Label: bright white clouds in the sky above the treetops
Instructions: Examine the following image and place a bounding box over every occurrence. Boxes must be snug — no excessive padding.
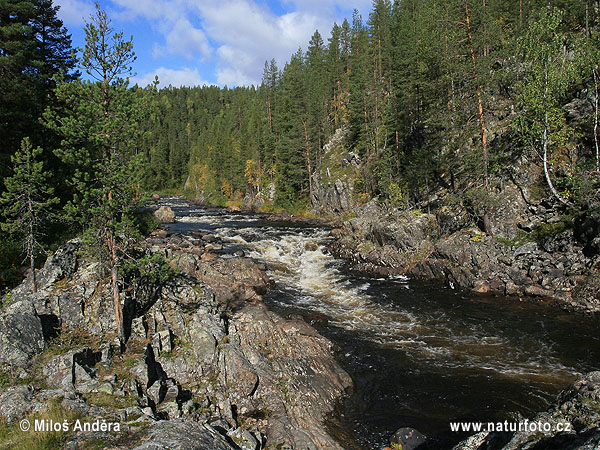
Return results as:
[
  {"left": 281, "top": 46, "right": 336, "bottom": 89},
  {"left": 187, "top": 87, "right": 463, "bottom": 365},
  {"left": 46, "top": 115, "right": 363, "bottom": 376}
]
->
[{"left": 62, "top": 0, "right": 371, "bottom": 86}]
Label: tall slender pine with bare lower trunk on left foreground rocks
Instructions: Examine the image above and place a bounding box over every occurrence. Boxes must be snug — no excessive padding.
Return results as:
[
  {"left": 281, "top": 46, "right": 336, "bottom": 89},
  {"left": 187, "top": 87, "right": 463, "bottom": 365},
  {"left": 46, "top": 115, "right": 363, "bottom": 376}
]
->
[{"left": 46, "top": 3, "right": 147, "bottom": 345}]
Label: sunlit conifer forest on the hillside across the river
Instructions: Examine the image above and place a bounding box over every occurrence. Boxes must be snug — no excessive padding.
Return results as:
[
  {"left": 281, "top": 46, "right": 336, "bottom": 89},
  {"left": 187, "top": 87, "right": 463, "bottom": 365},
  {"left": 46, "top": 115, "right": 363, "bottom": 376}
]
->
[{"left": 143, "top": 0, "right": 600, "bottom": 219}]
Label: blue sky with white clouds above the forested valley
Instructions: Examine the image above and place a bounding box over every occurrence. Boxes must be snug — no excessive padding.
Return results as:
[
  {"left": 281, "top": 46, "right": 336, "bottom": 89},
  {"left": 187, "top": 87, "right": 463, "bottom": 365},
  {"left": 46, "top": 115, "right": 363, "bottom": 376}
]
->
[{"left": 54, "top": 0, "right": 371, "bottom": 87}]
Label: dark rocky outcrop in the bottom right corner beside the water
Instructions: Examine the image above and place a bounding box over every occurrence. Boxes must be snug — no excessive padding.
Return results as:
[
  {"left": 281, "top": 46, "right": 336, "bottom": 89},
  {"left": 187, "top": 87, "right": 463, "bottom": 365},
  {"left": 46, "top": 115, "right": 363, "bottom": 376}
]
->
[{"left": 453, "top": 372, "right": 600, "bottom": 450}]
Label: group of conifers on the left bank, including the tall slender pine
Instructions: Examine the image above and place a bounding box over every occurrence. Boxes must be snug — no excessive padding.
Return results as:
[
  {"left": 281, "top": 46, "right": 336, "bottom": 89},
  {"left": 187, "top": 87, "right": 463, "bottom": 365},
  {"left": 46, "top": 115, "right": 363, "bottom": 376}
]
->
[{"left": 0, "top": 0, "right": 162, "bottom": 334}]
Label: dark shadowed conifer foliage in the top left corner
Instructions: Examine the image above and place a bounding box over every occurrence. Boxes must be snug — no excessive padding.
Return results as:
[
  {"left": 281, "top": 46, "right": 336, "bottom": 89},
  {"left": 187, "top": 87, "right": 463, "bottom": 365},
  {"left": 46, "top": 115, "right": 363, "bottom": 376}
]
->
[{"left": 0, "top": 0, "right": 74, "bottom": 185}]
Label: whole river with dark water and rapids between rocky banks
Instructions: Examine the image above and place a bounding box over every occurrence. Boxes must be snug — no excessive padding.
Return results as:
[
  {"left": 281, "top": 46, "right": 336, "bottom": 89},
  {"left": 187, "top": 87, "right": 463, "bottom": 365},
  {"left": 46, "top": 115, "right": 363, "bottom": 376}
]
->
[{"left": 163, "top": 199, "right": 600, "bottom": 450}]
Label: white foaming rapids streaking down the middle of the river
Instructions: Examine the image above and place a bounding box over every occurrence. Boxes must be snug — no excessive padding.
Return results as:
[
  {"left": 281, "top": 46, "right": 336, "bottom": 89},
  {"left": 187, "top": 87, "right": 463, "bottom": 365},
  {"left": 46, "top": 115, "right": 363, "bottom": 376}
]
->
[{"left": 189, "top": 209, "right": 577, "bottom": 380}]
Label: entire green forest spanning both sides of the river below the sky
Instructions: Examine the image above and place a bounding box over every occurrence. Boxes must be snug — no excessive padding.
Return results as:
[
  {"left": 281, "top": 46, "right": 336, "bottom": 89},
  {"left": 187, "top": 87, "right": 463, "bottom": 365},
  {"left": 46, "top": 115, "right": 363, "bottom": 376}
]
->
[{"left": 0, "top": 0, "right": 600, "bottom": 290}]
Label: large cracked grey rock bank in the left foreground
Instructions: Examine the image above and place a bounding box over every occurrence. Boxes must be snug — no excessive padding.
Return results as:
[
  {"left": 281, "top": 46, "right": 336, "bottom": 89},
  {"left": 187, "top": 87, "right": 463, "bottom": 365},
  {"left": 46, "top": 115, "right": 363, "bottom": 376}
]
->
[{"left": 0, "top": 214, "right": 352, "bottom": 450}]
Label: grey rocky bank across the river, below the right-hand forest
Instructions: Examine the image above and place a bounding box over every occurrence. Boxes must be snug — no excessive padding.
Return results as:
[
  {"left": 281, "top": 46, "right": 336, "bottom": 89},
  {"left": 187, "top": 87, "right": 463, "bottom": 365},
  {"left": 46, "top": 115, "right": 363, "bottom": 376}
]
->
[{"left": 331, "top": 201, "right": 600, "bottom": 313}]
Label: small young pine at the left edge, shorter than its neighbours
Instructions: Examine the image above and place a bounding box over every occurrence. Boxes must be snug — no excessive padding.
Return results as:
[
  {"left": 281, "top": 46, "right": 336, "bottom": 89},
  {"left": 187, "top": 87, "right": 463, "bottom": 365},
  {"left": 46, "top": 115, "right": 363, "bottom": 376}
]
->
[{"left": 0, "top": 138, "right": 58, "bottom": 293}]
